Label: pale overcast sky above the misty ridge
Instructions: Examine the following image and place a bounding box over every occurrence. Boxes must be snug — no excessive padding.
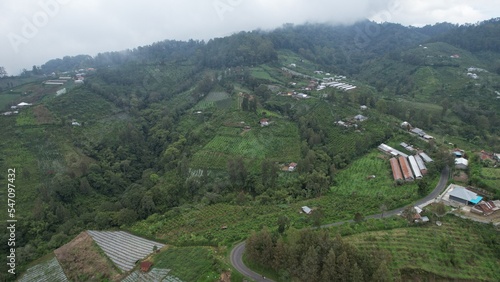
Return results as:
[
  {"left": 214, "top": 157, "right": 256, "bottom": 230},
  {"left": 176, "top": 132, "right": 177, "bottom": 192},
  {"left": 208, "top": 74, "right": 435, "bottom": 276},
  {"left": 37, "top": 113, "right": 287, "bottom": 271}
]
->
[{"left": 0, "top": 0, "right": 500, "bottom": 74}]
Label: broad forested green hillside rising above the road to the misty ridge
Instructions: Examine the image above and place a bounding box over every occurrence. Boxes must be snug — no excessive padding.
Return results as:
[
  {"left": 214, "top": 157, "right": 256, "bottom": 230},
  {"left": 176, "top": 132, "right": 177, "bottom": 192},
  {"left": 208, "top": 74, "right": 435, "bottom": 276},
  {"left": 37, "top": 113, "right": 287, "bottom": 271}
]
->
[{"left": 0, "top": 20, "right": 500, "bottom": 277}]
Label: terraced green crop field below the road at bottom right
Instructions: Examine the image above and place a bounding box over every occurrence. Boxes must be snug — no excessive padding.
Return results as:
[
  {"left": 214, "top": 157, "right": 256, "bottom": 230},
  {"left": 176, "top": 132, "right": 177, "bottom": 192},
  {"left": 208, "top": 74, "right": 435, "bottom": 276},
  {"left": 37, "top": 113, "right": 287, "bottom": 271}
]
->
[{"left": 345, "top": 215, "right": 500, "bottom": 281}]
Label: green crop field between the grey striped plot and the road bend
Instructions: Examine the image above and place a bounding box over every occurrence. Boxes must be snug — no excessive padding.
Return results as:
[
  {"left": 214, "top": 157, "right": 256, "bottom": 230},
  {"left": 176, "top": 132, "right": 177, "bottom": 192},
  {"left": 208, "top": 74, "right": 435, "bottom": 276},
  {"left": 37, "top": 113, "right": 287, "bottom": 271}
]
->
[{"left": 132, "top": 203, "right": 286, "bottom": 246}]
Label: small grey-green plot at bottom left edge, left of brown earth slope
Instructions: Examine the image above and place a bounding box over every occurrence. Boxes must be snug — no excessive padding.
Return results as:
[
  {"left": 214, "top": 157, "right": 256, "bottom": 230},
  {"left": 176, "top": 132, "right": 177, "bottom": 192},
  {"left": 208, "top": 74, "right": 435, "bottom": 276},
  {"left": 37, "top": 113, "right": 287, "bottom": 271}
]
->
[{"left": 19, "top": 257, "right": 68, "bottom": 282}]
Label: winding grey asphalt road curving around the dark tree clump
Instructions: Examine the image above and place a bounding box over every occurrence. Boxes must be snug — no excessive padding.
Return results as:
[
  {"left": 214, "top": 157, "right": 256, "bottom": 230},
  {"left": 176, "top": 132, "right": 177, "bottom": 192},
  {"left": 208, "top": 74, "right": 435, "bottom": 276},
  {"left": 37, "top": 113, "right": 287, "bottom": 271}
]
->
[{"left": 230, "top": 167, "right": 450, "bottom": 282}]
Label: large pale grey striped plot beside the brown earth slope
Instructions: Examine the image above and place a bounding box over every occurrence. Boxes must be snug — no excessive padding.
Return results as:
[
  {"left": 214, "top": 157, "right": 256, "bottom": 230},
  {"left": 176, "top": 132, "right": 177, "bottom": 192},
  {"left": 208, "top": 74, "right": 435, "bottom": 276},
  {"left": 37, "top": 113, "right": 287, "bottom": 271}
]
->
[{"left": 87, "top": 230, "right": 165, "bottom": 271}]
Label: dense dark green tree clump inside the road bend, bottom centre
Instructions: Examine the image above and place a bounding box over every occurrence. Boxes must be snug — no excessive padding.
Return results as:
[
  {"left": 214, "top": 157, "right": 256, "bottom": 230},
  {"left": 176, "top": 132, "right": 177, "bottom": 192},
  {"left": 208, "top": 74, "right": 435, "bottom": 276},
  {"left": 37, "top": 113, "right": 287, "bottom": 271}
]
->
[{"left": 245, "top": 229, "right": 398, "bottom": 282}]
